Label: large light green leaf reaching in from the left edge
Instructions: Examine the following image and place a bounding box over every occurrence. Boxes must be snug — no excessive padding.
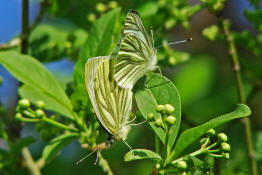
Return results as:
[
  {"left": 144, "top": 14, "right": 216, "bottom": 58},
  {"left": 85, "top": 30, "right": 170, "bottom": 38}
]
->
[{"left": 0, "top": 51, "right": 74, "bottom": 119}]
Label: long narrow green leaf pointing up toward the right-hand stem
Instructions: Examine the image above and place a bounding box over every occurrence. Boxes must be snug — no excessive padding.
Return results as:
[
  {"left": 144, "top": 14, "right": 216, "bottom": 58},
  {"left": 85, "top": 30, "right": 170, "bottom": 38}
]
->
[{"left": 170, "top": 104, "right": 251, "bottom": 160}]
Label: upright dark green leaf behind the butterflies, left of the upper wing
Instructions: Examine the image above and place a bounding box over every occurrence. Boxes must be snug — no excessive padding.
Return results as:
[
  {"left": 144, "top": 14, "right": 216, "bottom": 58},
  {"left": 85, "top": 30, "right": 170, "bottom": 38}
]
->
[{"left": 74, "top": 8, "right": 120, "bottom": 84}]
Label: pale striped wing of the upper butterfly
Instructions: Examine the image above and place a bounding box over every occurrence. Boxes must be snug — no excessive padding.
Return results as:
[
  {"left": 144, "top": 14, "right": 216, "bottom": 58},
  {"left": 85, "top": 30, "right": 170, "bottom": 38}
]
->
[{"left": 114, "top": 10, "right": 156, "bottom": 88}]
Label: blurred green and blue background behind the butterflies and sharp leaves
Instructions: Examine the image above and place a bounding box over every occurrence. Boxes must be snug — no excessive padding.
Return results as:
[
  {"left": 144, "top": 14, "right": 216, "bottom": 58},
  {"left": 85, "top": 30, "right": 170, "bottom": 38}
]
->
[{"left": 0, "top": 0, "right": 262, "bottom": 175}]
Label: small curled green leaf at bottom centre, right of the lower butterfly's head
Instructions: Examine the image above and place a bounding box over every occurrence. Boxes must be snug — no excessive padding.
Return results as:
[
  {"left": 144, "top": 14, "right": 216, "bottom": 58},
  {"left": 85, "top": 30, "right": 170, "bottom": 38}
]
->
[{"left": 124, "top": 149, "right": 162, "bottom": 162}]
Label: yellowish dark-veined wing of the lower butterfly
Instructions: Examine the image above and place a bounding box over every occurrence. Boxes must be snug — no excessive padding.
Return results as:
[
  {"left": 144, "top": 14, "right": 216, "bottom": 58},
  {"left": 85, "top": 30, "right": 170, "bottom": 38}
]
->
[{"left": 85, "top": 57, "right": 133, "bottom": 139}]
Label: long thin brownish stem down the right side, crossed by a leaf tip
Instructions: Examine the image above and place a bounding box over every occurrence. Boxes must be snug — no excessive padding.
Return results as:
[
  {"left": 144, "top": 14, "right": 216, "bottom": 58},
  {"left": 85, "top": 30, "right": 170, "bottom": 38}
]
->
[{"left": 221, "top": 19, "right": 257, "bottom": 175}]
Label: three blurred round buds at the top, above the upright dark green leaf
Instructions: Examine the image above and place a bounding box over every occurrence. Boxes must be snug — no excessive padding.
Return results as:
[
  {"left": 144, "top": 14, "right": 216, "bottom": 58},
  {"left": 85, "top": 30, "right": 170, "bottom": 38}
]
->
[{"left": 87, "top": 1, "right": 118, "bottom": 23}]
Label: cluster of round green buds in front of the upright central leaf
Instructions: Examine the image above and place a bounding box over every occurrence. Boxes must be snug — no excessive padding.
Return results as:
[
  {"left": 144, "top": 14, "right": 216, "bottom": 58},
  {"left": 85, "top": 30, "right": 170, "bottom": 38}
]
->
[{"left": 147, "top": 104, "right": 176, "bottom": 131}]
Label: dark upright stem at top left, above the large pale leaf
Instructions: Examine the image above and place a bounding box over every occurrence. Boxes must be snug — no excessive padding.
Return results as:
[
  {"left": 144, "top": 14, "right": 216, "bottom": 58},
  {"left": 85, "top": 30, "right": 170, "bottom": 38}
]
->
[{"left": 21, "top": 0, "right": 29, "bottom": 54}]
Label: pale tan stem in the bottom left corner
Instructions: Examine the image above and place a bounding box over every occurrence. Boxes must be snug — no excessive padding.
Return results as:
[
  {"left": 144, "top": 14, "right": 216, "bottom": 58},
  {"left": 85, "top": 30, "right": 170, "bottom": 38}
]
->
[{"left": 22, "top": 147, "right": 41, "bottom": 175}]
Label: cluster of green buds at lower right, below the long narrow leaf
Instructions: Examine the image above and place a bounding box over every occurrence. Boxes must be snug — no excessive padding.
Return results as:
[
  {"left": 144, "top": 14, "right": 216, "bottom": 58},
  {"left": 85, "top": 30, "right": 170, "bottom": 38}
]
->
[{"left": 200, "top": 129, "right": 230, "bottom": 159}]
